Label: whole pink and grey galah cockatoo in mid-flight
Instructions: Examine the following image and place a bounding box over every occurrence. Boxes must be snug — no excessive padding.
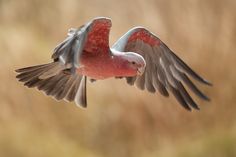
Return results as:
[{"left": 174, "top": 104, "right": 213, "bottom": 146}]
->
[{"left": 16, "top": 17, "right": 211, "bottom": 110}]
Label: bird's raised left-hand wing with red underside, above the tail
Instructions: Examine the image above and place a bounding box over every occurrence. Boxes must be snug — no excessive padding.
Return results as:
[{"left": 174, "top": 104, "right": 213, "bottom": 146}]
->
[{"left": 52, "top": 17, "right": 111, "bottom": 68}]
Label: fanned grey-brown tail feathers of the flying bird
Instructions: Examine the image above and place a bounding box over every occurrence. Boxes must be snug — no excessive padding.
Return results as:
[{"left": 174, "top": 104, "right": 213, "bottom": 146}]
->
[{"left": 16, "top": 62, "right": 87, "bottom": 107}]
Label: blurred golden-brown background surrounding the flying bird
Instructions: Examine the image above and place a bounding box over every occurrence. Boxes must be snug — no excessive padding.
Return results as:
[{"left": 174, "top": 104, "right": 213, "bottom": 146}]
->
[{"left": 0, "top": 0, "right": 236, "bottom": 157}]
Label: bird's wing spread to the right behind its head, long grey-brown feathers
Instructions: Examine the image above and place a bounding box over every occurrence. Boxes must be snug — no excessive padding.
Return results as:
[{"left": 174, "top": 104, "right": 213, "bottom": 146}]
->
[{"left": 112, "top": 27, "right": 211, "bottom": 110}]
